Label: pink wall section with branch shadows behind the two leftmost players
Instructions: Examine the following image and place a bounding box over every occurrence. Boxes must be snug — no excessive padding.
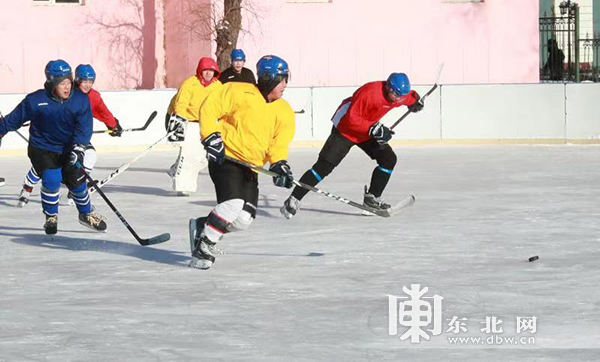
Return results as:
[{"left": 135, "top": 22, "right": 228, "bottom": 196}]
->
[{"left": 0, "top": 0, "right": 165, "bottom": 93}]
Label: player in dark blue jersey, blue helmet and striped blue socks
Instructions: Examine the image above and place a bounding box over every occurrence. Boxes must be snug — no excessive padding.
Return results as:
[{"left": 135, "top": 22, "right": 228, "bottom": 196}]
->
[{"left": 0, "top": 59, "right": 106, "bottom": 235}]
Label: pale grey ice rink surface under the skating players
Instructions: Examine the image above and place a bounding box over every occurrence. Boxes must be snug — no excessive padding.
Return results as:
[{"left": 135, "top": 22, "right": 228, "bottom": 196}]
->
[{"left": 0, "top": 145, "right": 600, "bottom": 361}]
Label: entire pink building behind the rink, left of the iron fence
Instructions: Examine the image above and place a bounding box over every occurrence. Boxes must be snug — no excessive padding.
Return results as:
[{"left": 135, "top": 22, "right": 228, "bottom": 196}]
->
[{"left": 0, "top": 0, "right": 539, "bottom": 93}]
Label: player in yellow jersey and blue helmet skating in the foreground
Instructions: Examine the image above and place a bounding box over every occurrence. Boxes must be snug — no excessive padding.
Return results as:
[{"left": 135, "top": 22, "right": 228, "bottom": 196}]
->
[{"left": 189, "top": 55, "right": 295, "bottom": 269}]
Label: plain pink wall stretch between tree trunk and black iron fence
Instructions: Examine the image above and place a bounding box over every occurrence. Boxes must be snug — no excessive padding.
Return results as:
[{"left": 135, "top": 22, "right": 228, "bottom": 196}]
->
[{"left": 238, "top": 0, "right": 539, "bottom": 86}]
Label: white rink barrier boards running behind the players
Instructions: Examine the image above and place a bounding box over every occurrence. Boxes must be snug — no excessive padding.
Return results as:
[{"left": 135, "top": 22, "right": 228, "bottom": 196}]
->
[{"left": 0, "top": 83, "right": 600, "bottom": 155}]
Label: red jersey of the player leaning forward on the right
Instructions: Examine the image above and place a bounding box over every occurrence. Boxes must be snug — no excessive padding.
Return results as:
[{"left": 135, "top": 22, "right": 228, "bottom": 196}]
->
[{"left": 331, "top": 81, "right": 417, "bottom": 143}]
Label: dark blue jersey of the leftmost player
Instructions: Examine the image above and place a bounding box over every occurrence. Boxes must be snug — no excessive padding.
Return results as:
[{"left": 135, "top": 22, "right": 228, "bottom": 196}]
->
[{"left": 0, "top": 89, "right": 93, "bottom": 153}]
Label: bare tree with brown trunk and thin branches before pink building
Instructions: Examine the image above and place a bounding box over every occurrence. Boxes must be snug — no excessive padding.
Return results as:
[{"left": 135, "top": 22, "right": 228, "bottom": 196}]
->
[{"left": 186, "top": 0, "right": 261, "bottom": 69}]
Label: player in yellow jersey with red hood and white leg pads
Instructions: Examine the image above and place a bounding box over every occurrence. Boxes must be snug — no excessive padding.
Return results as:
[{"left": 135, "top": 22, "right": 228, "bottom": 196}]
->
[{"left": 166, "top": 57, "right": 221, "bottom": 196}]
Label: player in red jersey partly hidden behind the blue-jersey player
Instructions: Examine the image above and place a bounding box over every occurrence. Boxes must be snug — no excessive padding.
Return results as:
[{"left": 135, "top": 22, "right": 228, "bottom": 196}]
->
[{"left": 17, "top": 64, "right": 123, "bottom": 207}]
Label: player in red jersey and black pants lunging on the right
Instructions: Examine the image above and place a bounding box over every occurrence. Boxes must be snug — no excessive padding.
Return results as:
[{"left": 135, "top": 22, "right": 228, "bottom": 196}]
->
[{"left": 280, "top": 73, "right": 424, "bottom": 219}]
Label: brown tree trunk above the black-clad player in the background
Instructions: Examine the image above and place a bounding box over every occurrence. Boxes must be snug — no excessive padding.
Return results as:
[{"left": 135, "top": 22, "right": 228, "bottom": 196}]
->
[{"left": 216, "top": 0, "right": 244, "bottom": 71}]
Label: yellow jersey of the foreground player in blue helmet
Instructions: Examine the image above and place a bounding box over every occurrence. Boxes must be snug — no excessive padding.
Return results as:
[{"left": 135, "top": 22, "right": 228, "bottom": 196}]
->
[{"left": 200, "top": 82, "right": 296, "bottom": 167}]
